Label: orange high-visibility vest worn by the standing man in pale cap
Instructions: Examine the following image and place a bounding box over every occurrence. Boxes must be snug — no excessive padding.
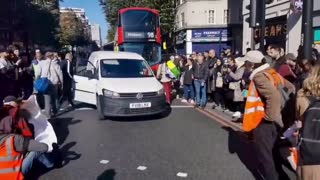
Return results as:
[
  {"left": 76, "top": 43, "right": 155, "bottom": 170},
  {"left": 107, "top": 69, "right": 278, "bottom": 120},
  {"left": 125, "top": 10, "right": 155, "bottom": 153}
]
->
[{"left": 242, "top": 69, "right": 284, "bottom": 132}]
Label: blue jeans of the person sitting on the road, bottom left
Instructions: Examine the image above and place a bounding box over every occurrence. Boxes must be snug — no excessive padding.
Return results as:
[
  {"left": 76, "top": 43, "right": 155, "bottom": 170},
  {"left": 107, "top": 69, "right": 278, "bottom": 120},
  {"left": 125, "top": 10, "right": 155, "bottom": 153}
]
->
[{"left": 21, "top": 151, "right": 54, "bottom": 175}]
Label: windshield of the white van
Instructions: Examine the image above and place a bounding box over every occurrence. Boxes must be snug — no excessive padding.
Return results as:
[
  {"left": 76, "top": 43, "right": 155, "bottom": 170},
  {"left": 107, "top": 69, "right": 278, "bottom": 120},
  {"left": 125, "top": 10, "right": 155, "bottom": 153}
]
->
[{"left": 100, "top": 59, "right": 153, "bottom": 78}]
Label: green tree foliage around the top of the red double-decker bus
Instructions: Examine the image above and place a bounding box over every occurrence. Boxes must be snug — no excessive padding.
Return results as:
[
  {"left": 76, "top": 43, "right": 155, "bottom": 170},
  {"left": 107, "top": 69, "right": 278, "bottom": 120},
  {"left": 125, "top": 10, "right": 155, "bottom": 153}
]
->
[{"left": 99, "top": 0, "right": 175, "bottom": 41}]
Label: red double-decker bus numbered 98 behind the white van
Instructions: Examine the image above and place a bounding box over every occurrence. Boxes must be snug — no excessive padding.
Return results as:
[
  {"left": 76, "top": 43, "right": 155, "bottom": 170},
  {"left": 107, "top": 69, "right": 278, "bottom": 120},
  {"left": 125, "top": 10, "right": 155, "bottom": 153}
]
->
[{"left": 115, "top": 7, "right": 161, "bottom": 70}]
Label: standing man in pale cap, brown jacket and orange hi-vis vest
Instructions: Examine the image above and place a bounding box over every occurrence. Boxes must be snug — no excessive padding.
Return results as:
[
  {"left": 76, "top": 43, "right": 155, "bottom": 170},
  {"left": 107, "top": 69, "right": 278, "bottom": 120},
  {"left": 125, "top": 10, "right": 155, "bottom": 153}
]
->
[{"left": 243, "top": 51, "right": 294, "bottom": 180}]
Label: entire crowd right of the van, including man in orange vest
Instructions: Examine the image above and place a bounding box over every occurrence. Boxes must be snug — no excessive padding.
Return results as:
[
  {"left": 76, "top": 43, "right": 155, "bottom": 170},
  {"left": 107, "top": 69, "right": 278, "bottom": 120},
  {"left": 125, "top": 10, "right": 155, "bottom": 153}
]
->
[{"left": 158, "top": 44, "right": 320, "bottom": 180}]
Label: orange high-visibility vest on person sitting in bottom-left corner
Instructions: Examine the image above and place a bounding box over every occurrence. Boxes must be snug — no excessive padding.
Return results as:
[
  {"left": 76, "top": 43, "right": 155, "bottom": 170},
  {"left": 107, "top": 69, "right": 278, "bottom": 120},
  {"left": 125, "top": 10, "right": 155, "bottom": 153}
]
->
[{"left": 0, "top": 136, "right": 23, "bottom": 180}]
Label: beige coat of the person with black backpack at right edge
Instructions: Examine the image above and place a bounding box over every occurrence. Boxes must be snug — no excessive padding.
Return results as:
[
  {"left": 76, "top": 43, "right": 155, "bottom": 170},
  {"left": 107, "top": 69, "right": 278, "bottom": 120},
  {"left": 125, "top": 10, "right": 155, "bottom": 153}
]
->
[{"left": 296, "top": 90, "right": 320, "bottom": 180}]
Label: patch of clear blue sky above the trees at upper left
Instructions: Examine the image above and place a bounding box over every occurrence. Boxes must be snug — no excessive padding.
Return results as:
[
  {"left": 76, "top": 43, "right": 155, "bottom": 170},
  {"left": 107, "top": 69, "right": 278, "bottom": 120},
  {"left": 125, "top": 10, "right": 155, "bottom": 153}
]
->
[{"left": 60, "top": 0, "right": 108, "bottom": 42}]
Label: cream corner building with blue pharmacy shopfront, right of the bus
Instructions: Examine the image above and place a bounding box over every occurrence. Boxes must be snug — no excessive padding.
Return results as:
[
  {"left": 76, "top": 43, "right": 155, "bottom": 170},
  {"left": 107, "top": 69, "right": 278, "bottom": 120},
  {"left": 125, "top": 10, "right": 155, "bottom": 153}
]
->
[{"left": 175, "top": 0, "right": 242, "bottom": 55}]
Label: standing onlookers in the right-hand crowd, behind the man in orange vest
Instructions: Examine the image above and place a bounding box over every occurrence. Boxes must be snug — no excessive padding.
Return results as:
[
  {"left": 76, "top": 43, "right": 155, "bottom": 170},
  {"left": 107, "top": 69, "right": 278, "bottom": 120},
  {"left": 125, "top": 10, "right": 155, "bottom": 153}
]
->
[{"left": 160, "top": 45, "right": 318, "bottom": 120}]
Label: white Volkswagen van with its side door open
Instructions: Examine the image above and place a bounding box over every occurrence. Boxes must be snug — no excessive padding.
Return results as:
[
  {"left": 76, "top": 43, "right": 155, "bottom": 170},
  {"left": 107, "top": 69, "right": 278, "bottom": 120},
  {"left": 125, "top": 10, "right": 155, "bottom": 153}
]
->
[{"left": 74, "top": 51, "right": 168, "bottom": 119}]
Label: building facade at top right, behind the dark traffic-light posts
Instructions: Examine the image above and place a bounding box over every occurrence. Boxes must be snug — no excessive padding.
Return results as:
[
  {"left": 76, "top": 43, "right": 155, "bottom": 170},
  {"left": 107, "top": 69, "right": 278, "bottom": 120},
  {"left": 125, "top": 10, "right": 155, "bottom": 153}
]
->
[{"left": 243, "top": 0, "right": 320, "bottom": 55}]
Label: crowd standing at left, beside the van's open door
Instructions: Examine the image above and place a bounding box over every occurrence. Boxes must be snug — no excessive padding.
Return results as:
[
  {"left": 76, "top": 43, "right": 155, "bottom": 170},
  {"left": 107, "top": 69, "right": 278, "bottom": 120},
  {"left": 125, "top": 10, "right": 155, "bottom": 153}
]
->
[{"left": 0, "top": 46, "right": 73, "bottom": 118}]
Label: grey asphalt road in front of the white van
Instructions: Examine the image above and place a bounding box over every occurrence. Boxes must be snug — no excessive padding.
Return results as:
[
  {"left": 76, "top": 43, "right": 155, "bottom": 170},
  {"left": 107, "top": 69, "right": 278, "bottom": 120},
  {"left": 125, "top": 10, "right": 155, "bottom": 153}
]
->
[{"left": 35, "top": 101, "right": 262, "bottom": 180}]
